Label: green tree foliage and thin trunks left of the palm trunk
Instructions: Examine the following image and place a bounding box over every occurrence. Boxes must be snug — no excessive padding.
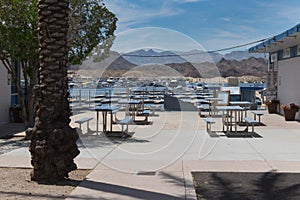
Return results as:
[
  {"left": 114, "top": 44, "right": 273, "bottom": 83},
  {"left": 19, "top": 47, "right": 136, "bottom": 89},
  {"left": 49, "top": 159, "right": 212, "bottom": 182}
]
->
[{"left": 0, "top": 0, "right": 39, "bottom": 126}]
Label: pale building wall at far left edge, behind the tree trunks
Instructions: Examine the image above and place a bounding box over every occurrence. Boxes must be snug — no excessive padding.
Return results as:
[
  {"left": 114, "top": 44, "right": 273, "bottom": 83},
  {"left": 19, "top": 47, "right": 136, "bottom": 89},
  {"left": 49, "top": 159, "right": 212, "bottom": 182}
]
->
[{"left": 0, "top": 62, "right": 11, "bottom": 124}]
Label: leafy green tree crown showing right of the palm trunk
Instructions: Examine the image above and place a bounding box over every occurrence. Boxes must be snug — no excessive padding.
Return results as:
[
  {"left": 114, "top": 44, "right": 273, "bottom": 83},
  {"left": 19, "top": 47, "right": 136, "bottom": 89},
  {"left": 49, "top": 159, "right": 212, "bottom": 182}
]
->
[{"left": 68, "top": 0, "right": 117, "bottom": 64}]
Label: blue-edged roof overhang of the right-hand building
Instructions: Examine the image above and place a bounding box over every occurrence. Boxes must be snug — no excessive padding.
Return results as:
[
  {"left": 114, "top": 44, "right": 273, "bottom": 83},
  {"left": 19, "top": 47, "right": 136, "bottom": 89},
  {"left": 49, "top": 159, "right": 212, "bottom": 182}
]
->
[{"left": 249, "top": 24, "right": 300, "bottom": 53}]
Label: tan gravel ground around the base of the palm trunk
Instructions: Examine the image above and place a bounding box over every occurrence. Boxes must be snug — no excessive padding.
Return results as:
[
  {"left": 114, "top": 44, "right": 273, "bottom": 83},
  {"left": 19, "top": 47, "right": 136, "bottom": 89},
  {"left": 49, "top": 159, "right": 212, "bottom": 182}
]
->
[{"left": 0, "top": 137, "right": 90, "bottom": 200}]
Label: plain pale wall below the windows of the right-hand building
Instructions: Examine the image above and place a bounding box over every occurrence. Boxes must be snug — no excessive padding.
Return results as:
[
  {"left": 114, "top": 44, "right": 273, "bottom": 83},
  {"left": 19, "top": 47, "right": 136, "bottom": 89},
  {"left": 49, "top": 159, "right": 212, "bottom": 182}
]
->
[{"left": 277, "top": 57, "right": 300, "bottom": 120}]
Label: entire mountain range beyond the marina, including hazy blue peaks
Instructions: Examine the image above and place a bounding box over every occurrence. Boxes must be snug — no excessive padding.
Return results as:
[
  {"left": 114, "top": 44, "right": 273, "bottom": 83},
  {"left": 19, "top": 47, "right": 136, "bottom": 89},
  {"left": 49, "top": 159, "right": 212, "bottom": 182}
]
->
[{"left": 73, "top": 49, "right": 268, "bottom": 78}]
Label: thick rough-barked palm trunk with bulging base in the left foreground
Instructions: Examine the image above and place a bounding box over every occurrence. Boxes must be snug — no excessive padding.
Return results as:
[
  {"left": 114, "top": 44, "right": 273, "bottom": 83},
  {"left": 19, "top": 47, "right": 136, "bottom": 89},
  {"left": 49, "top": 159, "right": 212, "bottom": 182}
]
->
[{"left": 30, "top": 0, "right": 79, "bottom": 183}]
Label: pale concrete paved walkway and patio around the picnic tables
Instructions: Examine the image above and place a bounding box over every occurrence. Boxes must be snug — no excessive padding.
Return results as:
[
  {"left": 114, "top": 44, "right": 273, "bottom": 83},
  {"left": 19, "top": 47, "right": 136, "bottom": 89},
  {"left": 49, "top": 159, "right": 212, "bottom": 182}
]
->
[{"left": 0, "top": 111, "right": 300, "bottom": 200}]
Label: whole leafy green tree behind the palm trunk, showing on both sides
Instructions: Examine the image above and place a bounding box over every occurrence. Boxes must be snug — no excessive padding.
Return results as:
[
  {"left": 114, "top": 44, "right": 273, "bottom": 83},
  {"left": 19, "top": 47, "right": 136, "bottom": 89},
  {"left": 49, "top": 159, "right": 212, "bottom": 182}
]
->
[{"left": 0, "top": 0, "right": 117, "bottom": 127}]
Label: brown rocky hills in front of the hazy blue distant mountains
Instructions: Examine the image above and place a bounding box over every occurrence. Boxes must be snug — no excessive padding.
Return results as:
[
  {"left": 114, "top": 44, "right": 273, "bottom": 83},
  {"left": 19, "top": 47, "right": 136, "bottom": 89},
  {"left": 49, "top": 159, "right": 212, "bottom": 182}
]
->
[{"left": 72, "top": 53, "right": 268, "bottom": 78}]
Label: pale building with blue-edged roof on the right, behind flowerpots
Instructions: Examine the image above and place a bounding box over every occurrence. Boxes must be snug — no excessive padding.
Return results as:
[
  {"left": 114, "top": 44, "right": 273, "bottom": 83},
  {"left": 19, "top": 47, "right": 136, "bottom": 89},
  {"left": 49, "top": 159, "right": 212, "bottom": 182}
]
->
[{"left": 249, "top": 24, "right": 300, "bottom": 120}]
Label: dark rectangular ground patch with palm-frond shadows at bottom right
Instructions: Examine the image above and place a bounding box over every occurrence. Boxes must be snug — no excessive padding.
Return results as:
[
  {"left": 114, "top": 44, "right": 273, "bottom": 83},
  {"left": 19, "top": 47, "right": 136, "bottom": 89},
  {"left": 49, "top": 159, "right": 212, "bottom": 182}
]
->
[{"left": 192, "top": 171, "right": 300, "bottom": 200}]
